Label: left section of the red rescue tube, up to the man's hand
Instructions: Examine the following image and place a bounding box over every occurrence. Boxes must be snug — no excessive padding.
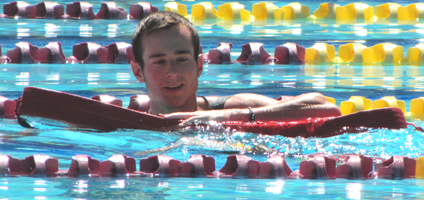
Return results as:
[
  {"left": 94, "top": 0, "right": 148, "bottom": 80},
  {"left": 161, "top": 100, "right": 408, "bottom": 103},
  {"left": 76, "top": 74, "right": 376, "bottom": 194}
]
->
[{"left": 17, "top": 87, "right": 179, "bottom": 131}]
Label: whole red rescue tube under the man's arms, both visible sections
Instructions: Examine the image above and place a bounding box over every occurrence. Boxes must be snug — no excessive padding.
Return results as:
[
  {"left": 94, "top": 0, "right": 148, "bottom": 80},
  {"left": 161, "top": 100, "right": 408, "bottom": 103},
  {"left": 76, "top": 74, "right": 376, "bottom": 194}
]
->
[{"left": 17, "top": 87, "right": 407, "bottom": 137}]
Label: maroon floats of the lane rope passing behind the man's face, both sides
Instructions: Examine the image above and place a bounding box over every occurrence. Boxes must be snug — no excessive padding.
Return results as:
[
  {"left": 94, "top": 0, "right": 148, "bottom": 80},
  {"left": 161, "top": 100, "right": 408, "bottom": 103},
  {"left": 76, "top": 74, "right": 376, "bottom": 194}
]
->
[{"left": 0, "top": 42, "right": 305, "bottom": 65}]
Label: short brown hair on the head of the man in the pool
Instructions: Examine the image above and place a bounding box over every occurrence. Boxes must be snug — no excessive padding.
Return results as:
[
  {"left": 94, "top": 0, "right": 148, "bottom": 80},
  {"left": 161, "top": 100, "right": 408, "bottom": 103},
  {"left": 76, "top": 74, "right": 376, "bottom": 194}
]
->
[{"left": 132, "top": 11, "right": 200, "bottom": 69}]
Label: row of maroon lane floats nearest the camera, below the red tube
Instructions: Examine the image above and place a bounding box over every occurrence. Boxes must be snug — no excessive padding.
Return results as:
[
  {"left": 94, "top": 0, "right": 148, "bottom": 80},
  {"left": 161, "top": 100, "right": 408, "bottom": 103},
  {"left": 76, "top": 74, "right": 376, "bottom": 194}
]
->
[{"left": 0, "top": 154, "right": 416, "bottom": 180}]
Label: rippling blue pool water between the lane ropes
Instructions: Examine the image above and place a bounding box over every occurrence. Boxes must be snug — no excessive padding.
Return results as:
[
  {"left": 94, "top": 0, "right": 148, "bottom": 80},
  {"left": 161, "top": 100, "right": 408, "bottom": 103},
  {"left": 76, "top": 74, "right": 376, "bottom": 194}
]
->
[{"left": 0, "top": 0, "right": 424, "bottom": 199}]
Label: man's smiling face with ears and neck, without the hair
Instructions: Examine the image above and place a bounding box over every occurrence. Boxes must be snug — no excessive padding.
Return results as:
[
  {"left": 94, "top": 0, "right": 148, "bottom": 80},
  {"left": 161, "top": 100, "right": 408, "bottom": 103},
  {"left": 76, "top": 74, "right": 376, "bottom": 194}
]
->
[{"left": 132, "top": 25, "right": 203, "bottom": 114}]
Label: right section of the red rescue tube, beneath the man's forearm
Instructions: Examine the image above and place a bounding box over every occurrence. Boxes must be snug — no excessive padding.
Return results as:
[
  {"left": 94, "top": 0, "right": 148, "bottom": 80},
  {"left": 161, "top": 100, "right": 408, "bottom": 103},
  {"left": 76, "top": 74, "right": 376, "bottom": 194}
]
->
[{"left": 223, "top": 108, "right": 407, "bottom": 137}]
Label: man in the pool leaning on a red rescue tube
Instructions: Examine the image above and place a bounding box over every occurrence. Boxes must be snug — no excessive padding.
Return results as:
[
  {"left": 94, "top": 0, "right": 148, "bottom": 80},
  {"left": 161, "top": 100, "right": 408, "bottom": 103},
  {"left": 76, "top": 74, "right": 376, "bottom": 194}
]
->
[{"left": 131, "top": 11, "right": 341, "bottom": 124}]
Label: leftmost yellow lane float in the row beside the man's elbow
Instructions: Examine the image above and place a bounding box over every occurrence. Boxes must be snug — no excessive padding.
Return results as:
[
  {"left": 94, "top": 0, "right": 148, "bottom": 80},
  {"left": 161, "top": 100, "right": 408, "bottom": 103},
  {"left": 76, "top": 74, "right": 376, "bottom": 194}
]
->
[{"left": 340, "top": 96, "right": 372, "bottom": 115}]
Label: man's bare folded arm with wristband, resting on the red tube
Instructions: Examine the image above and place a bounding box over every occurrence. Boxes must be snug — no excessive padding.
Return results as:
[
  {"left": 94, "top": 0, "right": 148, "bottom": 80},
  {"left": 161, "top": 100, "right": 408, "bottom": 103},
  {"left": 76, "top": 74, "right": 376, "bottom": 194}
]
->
[{"left": 165, "top": 93, "right": 341, "bottom": 123}]
